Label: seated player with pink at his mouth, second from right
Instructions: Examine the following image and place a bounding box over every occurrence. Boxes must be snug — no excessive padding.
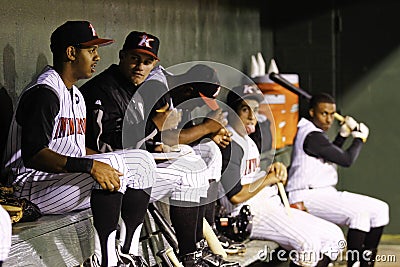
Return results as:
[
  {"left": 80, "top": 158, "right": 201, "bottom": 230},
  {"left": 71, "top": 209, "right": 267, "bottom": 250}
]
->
[{"left": 221, "top": 85, "right": 344, "bottom": 266}]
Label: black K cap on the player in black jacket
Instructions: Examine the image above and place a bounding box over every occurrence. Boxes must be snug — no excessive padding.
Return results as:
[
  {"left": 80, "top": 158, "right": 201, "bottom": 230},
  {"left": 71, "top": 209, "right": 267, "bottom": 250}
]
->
[{"left": 122, "top": 31, "right": 160, "bottom": 60}]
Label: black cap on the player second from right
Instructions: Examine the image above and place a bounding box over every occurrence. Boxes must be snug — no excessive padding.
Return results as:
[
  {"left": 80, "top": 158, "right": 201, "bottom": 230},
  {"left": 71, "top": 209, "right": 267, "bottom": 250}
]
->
[{"left": 226, "top": 84, "right": 265, "bottom": 110}]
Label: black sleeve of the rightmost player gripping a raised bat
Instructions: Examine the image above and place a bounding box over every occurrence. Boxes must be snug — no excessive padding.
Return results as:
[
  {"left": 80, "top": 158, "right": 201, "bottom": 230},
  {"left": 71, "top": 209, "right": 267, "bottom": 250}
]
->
[{"left": 303, "top": 132, "right": 363, "bottom": 167}]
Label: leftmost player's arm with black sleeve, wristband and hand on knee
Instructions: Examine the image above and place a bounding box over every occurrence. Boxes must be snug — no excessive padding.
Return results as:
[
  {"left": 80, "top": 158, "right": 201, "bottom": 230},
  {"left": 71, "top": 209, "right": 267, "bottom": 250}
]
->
[{"left": 16, "top": 85, "right": 122, "bottom": 190}]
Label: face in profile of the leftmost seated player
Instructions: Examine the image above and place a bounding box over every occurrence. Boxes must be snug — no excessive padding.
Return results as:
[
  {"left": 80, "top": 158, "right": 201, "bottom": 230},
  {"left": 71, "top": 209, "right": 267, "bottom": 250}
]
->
[{"left": 73, "top": 45, "right": 100, "bottom": 80}]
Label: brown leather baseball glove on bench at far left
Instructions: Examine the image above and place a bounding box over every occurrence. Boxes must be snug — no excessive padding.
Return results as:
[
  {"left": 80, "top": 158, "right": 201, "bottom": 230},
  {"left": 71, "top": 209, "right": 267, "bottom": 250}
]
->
[{"left": 0, "top": 186, "right": 42, "bottom": 223}]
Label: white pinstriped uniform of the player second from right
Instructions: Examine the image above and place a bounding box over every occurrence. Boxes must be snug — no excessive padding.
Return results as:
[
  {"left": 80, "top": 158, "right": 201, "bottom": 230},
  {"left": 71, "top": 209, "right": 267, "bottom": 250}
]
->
[{"left": 228, "top": 127, "right": 344, "bottom": 266}]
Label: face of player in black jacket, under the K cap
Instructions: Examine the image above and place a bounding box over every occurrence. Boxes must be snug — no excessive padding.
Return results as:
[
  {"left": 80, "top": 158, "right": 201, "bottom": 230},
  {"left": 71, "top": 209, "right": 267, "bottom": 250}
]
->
[{"left": 119, "top": 50, "right": 157, "bottom": 85}]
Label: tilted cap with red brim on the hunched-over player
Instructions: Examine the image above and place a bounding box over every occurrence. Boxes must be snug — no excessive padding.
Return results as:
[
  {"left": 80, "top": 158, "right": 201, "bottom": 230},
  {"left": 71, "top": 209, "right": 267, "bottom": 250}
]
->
[{"left": 180, "top": 64, "right": 221, "bottom": 110}]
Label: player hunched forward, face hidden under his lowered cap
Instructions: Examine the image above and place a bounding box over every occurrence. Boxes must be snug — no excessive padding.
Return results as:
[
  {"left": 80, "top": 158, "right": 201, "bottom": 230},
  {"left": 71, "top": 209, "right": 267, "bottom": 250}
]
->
[{"left": 147, "top": 64, "right": 231, "bottom": 224}]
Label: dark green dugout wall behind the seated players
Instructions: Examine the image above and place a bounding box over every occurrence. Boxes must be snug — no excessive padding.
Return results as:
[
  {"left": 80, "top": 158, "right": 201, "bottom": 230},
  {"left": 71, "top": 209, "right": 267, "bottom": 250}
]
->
[{"left": 0, "top": 0, "right": 400, "bottom": 234}]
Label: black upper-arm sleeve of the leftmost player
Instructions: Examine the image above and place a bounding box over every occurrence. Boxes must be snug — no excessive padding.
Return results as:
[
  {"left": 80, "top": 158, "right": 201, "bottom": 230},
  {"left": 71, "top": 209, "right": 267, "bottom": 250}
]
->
[{"left": 16, "top": 85, "right": 60, "bottom": 162}]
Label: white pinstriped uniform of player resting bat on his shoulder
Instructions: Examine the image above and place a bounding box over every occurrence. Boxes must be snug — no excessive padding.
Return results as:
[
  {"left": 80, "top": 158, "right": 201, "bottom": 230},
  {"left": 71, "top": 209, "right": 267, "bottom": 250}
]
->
[{"left": 286, "top": 118, "right": 389, "bottom": 232}]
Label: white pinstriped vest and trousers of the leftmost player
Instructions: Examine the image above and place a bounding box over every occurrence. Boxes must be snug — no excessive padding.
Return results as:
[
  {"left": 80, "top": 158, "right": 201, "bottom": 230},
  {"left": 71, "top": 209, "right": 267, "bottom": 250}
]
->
[{"left": 5, "top": 67, "right": 156, "bottom": 214}]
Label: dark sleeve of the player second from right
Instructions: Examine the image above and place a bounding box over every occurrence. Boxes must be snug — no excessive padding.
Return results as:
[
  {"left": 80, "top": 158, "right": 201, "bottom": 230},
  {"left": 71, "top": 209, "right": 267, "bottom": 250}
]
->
[{"left": 221, "top": 142, "right": 244, "bottom": 199}]
